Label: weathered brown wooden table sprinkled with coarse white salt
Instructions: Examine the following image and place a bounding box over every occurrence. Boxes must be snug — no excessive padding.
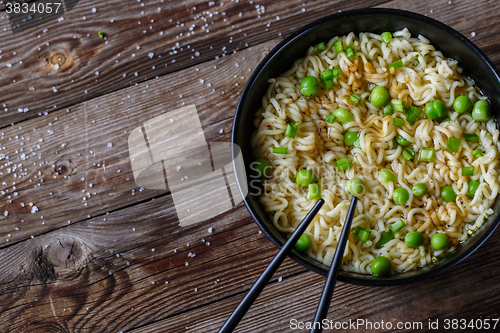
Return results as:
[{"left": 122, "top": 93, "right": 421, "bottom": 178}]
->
[{"left": 0, "top": 0, "right": 500, "bottom": 333}]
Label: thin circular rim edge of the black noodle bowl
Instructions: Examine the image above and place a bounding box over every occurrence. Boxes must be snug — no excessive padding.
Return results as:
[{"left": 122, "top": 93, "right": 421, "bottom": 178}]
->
[{"left": 231, "top": 8, "right": 500, "bottom": 286}]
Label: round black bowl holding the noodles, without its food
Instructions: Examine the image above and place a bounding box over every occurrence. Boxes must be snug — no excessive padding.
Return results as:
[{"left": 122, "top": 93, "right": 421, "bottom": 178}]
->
[{"left": 232, "top": 8, "right": 500, "bottom": 285}]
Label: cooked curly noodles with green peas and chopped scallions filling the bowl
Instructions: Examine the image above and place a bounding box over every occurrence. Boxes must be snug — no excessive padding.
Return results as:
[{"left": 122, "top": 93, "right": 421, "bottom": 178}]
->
[{"left": 251, "top": 29, "right": 499, "bottom": 275}]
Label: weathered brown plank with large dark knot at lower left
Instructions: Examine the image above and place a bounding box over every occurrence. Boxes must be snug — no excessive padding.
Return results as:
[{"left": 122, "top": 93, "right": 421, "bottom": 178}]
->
[{"left": 0, "top": 196, "right": 304, "bottom": 332}]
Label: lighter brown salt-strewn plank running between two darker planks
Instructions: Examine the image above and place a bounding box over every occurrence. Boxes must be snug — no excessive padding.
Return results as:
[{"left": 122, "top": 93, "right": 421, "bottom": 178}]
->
[{"left": 0, "top": 42, "right": 275, "bottom": 248}]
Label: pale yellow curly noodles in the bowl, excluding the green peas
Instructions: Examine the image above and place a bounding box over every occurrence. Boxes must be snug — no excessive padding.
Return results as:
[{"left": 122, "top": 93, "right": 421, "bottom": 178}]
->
[{"left": 251, "top": 29, "right": 499, "bottom": 274}]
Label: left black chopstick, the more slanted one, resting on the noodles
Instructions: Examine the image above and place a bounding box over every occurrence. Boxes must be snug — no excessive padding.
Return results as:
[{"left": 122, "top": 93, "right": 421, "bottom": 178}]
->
[{"left": 219, "top": 199, "right": 325, "bottom": 333}]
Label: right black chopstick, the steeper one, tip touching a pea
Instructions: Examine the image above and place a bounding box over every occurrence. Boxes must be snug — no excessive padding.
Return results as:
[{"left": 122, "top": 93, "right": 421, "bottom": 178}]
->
[{"left": 310, "top": 196, "right": 358, "bottom": 333}]
